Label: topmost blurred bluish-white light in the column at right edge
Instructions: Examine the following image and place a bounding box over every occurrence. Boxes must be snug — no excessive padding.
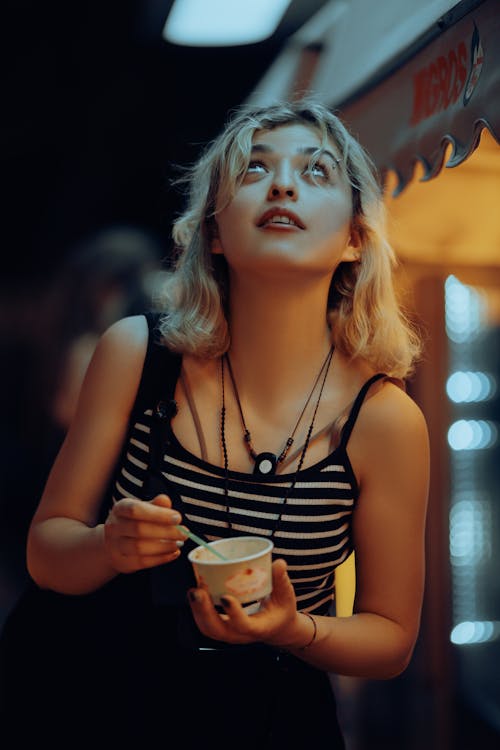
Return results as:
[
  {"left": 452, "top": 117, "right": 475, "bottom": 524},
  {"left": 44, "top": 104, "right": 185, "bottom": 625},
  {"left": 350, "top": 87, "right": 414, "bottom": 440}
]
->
[{"left": 444, "top": 276, "right": 485, "bottom": 344}]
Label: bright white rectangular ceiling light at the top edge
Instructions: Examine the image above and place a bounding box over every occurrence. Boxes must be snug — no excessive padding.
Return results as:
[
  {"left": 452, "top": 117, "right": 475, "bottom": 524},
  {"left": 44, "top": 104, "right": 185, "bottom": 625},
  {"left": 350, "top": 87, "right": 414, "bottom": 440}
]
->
[{"left": 163, "top": 0, "right": 291, "bottom": 47}]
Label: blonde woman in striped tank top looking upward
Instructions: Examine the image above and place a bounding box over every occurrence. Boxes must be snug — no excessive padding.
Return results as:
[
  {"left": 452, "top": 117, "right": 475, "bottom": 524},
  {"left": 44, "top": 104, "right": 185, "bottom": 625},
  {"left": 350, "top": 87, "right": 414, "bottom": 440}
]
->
[{"left": 15, "top": 100, "right": 429, "bottom": 748}]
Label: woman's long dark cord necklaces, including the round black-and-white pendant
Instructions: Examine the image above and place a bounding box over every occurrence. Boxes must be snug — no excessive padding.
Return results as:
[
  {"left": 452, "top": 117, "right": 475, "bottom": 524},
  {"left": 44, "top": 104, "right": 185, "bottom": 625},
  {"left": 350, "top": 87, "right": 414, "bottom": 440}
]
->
[{"left": 220, "top": 346, "right": 334, "bottom": 536}]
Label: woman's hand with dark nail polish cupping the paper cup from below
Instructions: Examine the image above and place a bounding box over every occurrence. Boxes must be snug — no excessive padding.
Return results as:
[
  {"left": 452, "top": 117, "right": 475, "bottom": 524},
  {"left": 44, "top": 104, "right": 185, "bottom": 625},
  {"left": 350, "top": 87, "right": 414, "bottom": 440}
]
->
[{"left": 189, "top": 560, "right": 305, "bottom": 647}]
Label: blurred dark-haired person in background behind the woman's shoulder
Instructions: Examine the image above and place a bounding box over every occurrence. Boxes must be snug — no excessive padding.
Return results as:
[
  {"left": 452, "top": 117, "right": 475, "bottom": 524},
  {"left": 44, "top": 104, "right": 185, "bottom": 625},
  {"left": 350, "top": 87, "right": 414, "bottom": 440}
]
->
[{"left": 40, "top": 225, "right": 161, "bottom": 456}]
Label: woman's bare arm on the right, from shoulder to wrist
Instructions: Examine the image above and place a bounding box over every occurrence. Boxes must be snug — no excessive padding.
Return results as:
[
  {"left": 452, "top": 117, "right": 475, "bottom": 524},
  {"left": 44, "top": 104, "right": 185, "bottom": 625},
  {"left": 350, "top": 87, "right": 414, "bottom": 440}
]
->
[{"left": 290, "top": 385, "right": 429, "bottom": 678}]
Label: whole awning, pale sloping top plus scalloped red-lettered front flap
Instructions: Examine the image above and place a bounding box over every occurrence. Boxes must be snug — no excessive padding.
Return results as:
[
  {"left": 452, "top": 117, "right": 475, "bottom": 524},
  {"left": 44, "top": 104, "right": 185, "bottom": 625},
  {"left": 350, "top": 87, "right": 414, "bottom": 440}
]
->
[{"left": 249, "top": 0, "right": 500, "bottom": 195}]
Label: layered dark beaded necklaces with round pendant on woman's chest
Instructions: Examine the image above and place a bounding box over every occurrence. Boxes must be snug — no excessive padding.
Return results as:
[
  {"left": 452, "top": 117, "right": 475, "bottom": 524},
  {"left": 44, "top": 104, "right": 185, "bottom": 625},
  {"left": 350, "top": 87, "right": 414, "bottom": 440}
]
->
[{"left": 220, "top": 346, "right": 334, "bottom": 534}]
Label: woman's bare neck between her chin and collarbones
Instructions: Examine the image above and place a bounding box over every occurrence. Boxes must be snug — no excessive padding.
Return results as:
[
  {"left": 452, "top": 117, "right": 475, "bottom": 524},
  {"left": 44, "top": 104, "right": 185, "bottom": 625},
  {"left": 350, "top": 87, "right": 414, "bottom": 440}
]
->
[{"left": 229, "top": 278, "right": 331, "bottom": 408}]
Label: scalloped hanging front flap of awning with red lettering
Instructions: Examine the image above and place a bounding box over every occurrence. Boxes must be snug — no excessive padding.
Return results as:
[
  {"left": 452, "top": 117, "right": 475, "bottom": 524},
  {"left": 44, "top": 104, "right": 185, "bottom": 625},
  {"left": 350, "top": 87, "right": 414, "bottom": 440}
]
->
[{"left": 340, "top": 0, "right": 500, "bottom": 194}]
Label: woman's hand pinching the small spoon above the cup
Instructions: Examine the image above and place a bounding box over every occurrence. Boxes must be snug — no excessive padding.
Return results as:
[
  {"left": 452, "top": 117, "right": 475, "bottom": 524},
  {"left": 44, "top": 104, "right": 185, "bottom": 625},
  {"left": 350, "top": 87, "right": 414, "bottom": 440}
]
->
[{"left": 104, "top": 495, "right": 186, "bottom": 573}]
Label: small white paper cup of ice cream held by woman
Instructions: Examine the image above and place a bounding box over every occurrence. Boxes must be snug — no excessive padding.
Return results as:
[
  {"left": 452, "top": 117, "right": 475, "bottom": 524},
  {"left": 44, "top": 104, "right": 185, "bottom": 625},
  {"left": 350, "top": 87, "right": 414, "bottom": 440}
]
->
[{"left": 188, "top": 536, "right": 274, "bottom": 614}]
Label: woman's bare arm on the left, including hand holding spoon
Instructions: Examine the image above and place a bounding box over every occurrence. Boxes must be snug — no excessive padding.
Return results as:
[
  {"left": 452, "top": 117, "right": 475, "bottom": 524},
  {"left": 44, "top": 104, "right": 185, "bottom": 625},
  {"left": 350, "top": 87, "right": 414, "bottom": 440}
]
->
[{"left": 27, "top": 316, "right": 186, "bottom": 594}]
